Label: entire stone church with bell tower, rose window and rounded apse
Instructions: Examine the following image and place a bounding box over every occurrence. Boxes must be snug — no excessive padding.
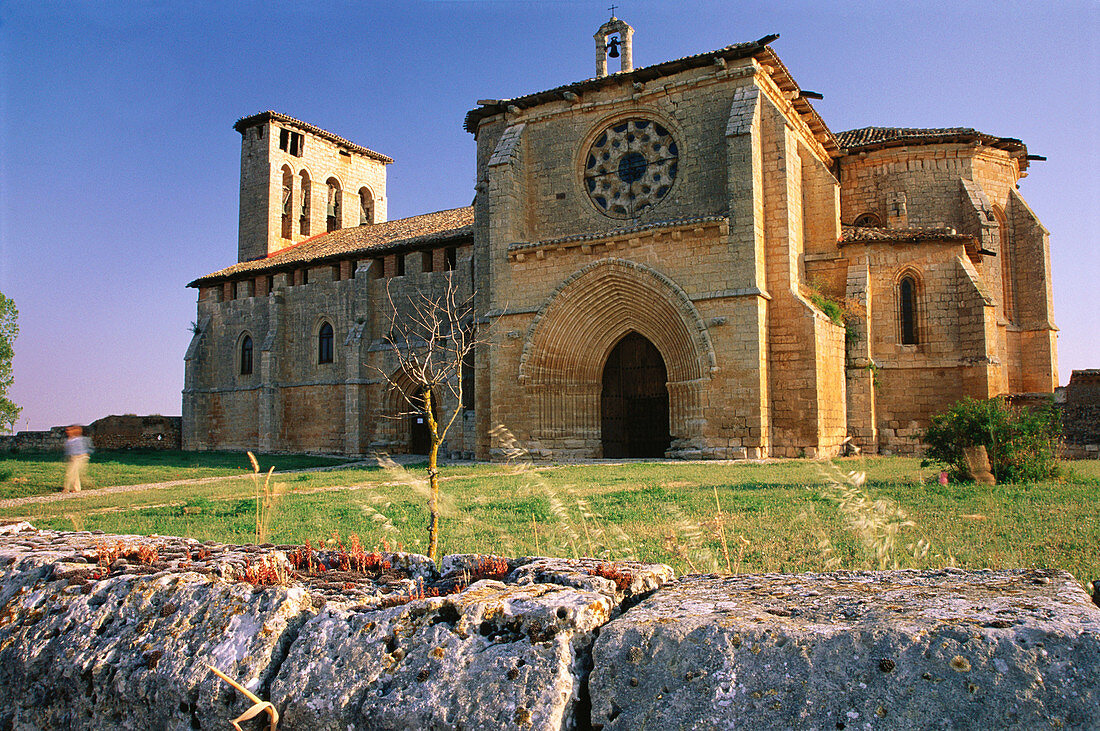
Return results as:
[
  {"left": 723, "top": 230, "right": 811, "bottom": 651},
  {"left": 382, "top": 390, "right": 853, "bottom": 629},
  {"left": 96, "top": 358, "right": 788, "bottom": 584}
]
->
[{"left": 183, "top": 18, "right": 1058, "bottom": 459}]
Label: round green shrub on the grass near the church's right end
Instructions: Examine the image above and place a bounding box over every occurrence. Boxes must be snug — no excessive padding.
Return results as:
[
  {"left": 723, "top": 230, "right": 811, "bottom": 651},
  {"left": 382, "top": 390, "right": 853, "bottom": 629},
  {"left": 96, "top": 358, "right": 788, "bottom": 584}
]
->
[{"left": 924, "top": 398, "right": 1062, "bottom": 483}]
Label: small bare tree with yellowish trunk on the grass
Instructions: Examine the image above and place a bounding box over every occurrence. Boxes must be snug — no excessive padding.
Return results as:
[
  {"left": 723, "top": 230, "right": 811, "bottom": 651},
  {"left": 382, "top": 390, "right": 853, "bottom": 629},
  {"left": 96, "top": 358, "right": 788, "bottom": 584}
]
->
[{"left": 380, "top": 272, "right": 483, "bottom": 561}]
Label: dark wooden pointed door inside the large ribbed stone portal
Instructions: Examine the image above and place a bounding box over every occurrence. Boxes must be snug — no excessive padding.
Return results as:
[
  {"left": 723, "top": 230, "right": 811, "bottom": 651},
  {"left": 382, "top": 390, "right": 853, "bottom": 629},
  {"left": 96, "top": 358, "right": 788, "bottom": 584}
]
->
[{"left": 600, "top": 332, "right": 672, "bottom": 457}]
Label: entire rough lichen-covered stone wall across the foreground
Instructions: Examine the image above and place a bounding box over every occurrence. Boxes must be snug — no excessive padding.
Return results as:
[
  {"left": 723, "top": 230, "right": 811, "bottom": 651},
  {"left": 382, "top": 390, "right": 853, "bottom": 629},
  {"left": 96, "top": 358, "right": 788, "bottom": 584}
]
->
[{"left": 0, "top": 523, "right": 1100, "bottom": 730}]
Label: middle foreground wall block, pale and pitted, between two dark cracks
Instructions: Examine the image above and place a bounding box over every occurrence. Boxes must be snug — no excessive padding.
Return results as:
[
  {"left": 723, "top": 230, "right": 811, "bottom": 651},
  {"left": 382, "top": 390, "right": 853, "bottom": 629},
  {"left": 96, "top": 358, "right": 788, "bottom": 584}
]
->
[{"left": 272, "top": 579, "right": 613, "bottom": 729}]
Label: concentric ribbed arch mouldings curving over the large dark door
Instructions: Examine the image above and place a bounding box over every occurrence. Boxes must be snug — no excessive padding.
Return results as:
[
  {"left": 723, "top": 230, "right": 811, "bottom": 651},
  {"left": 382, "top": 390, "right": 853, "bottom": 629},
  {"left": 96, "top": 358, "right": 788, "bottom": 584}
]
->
[{"left": 519, "top": 258, "right": 716, "bottom": 385}]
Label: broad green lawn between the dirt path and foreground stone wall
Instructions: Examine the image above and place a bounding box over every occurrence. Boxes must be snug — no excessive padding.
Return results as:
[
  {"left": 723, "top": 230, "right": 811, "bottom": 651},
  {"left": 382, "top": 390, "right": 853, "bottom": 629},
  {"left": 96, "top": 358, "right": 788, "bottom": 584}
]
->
[{"left": 0, "top": 457, "right": 1100, "bottom": 583}]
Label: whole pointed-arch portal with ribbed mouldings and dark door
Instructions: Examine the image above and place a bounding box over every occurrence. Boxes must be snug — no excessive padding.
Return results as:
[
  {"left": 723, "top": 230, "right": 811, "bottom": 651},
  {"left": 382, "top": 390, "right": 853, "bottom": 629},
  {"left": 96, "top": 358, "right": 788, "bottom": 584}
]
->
[{"left": 519, "top": 258, "right": 715, "bottom": 457}]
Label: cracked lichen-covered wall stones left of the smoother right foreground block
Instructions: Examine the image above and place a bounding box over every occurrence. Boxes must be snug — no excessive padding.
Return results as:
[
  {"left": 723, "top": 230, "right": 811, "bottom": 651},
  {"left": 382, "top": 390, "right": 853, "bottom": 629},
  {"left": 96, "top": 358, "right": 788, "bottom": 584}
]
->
[{"left": 0, "top": 523, "right": 672, "bottom": 730}]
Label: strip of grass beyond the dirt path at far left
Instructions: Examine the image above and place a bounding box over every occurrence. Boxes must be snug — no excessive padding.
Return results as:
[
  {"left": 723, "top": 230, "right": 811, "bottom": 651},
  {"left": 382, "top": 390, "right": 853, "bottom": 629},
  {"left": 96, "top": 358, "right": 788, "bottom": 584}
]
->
[{"left": 0, "top": 450, "right": 347, "bottom": 499}]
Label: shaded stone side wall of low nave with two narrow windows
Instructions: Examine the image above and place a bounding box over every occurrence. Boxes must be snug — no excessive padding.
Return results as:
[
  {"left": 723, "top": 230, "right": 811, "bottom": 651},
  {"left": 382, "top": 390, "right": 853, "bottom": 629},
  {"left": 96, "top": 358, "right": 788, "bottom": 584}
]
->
[{"left": 183, "top": 241, "right": 472, "bottom": 455}]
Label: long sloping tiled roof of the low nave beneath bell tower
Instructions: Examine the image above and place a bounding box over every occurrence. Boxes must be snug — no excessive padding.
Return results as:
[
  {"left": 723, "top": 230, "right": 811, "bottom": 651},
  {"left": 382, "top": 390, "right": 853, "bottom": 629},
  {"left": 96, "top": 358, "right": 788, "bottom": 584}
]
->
[{"left": 187, "top": 206, "right": 474, "bottom": 287}]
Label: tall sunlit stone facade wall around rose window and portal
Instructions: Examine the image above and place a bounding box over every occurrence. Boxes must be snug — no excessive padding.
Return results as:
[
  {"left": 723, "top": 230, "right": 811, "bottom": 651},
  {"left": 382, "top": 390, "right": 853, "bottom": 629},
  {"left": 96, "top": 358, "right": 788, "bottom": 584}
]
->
[{"left": 475, "top": 60, "right": 844, "bottom": 457}]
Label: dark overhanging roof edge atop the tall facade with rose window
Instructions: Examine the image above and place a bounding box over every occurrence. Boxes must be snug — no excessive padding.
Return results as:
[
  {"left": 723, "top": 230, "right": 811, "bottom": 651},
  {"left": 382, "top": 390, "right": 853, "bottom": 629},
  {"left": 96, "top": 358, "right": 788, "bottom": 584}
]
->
[{"left": 463, "top": 34, "right": 839, "bottom": 153}]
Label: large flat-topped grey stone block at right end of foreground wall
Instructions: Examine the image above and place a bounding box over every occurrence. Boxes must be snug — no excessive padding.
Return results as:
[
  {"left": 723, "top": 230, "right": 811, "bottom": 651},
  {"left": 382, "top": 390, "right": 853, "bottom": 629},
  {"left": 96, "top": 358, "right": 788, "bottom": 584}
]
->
[{"left": 590, "top": 569, "right": 1100, "bottom": 731}]
